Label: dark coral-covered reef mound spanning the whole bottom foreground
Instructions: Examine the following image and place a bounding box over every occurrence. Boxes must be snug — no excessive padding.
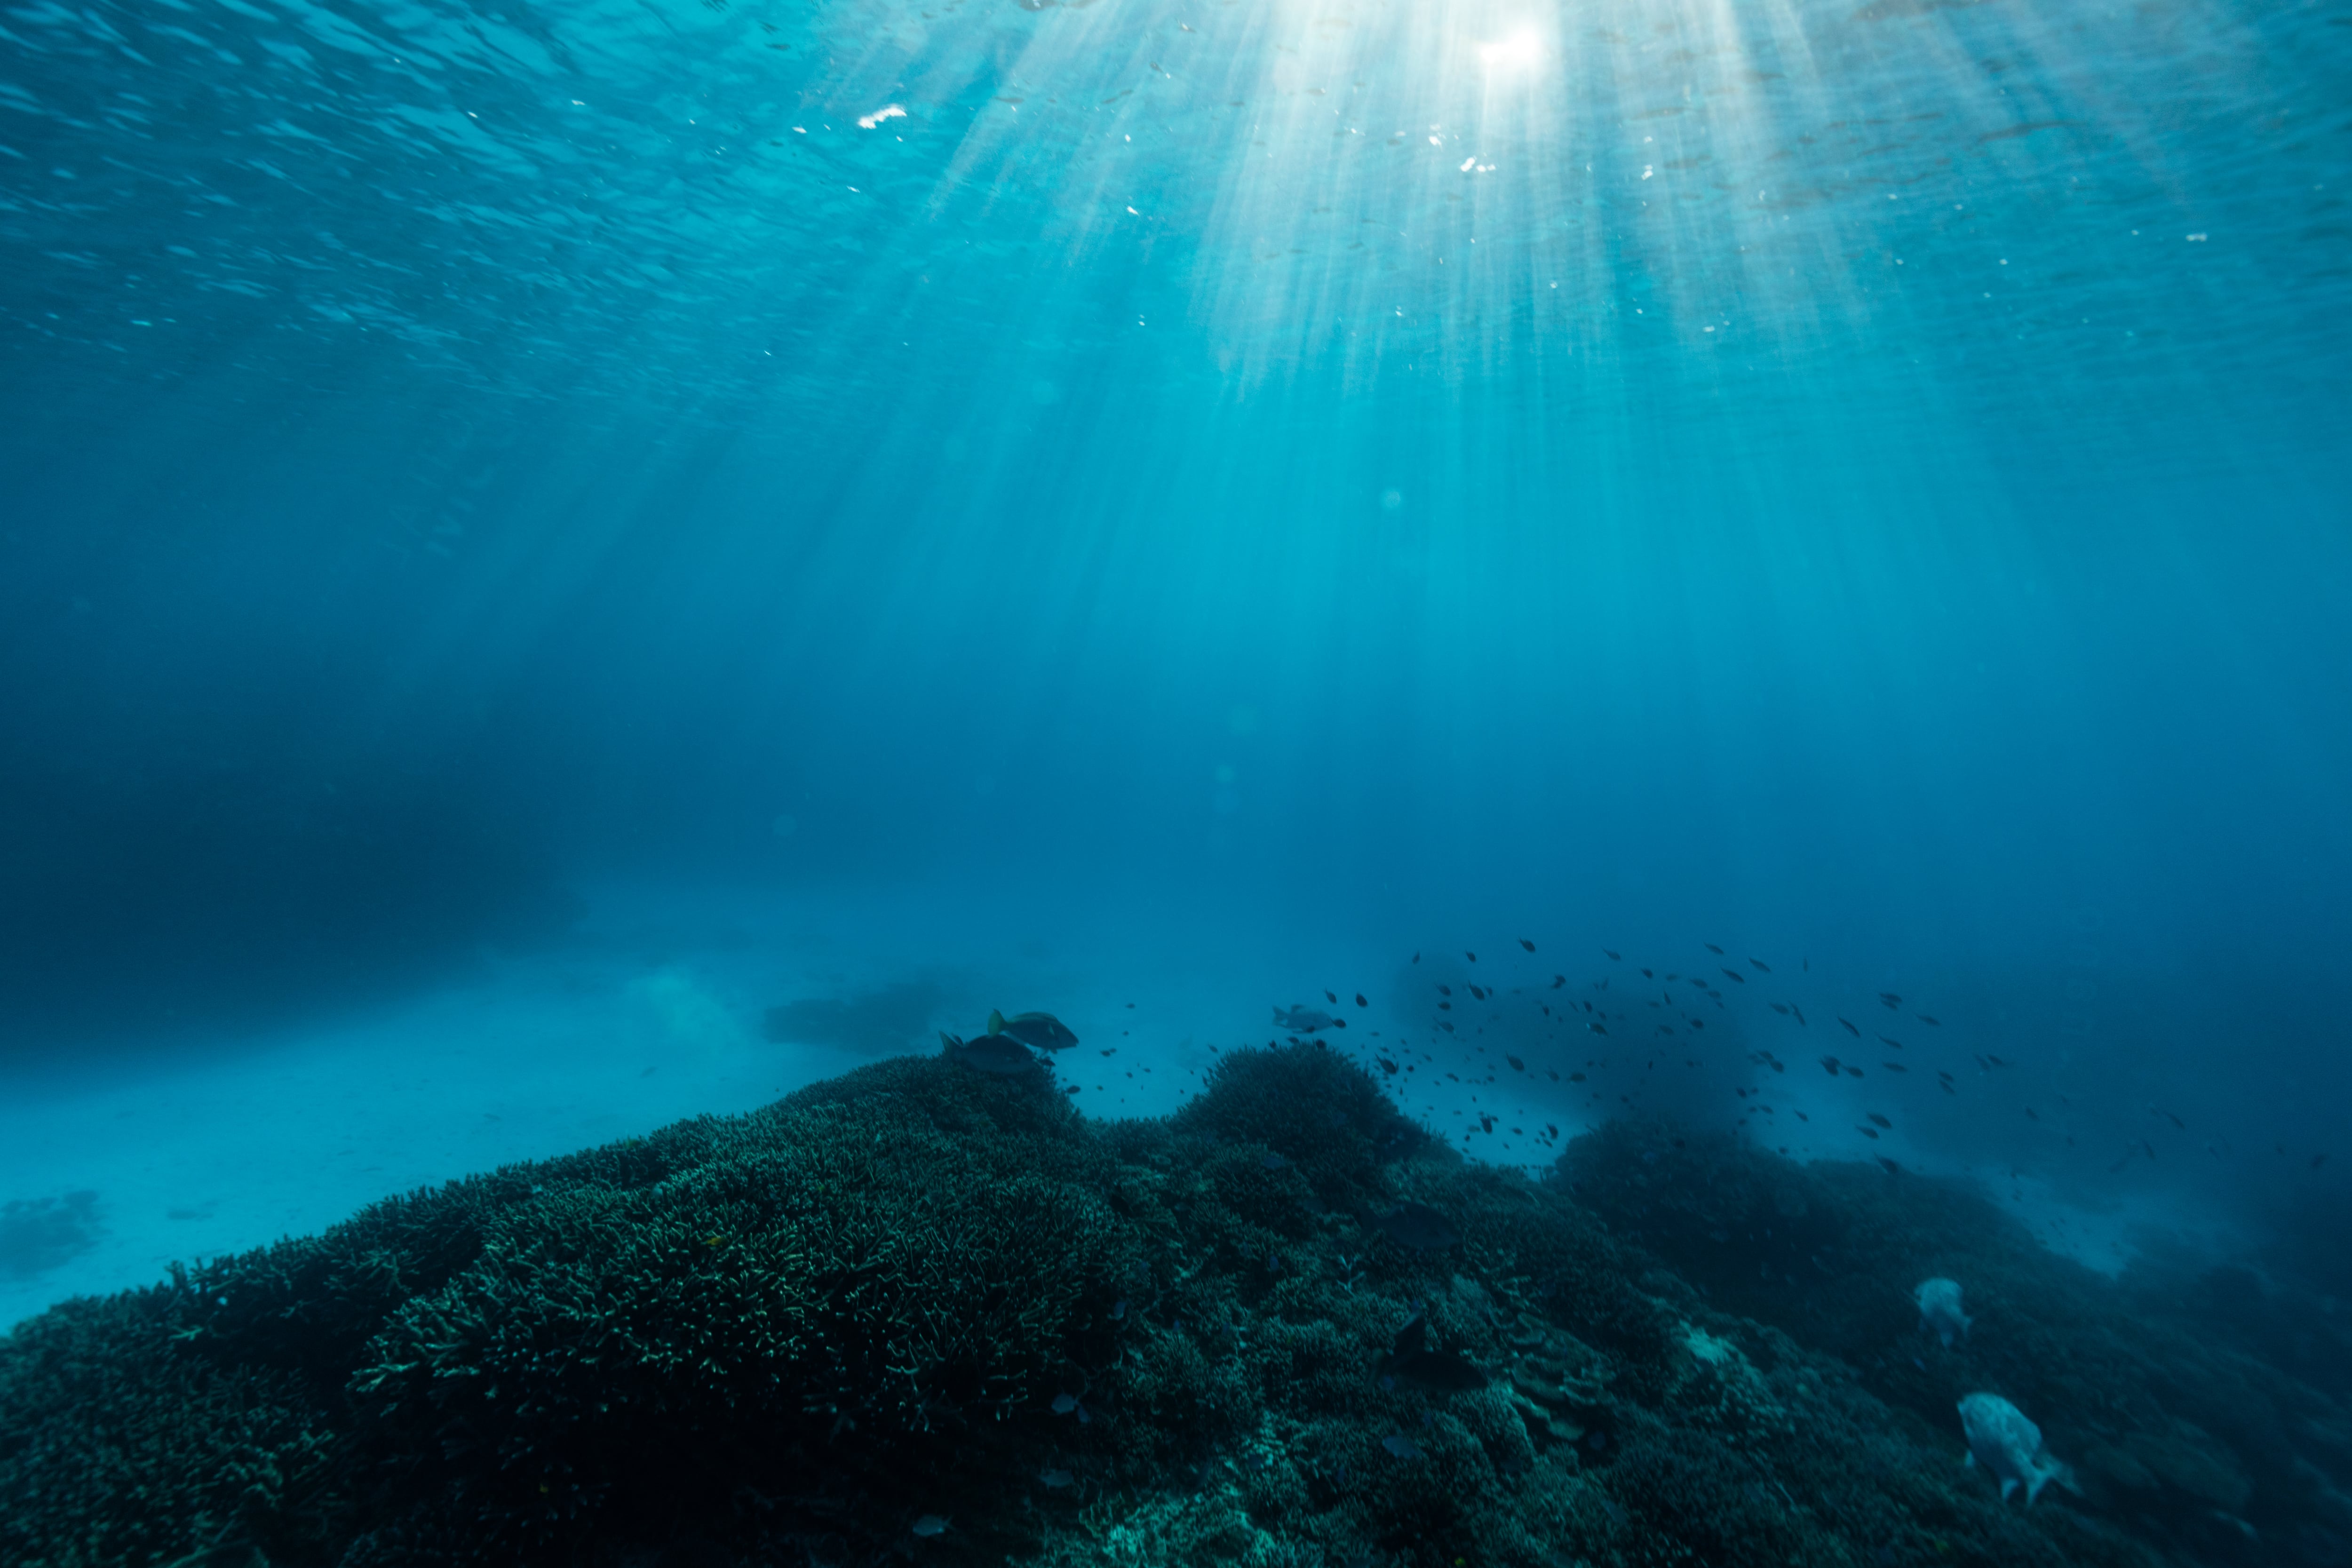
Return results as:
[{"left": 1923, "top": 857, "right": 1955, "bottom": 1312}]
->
[{"left": 0, "top": 1044, "right": 2352, "bottom": 1568}]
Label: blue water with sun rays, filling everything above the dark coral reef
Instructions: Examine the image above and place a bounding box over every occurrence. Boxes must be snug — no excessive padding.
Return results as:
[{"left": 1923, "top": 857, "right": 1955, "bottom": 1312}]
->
[{"left": 0, "top": 0, "right": 2352, "bottom": 1319}]
